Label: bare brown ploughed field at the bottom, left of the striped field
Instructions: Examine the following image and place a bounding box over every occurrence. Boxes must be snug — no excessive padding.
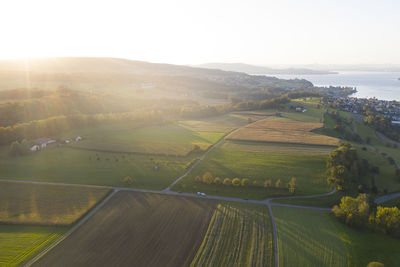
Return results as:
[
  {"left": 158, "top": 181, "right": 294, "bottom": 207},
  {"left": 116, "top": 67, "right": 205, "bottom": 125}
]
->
[{"left": 34, "top": 191, "right": 217, "bottom": 266}]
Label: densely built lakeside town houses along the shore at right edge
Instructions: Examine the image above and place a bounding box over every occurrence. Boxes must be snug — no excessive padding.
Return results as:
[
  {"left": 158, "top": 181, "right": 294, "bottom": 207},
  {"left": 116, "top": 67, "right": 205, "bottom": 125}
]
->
[{"left": 324, "top": 97, "right": 400, "bottom": 123}]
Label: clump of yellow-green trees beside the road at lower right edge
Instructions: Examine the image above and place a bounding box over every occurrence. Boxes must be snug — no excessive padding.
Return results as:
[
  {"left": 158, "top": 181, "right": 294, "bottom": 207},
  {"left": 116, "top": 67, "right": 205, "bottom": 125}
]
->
[{"left": 332, "top": 194, "right": 400, "bottom": 238}]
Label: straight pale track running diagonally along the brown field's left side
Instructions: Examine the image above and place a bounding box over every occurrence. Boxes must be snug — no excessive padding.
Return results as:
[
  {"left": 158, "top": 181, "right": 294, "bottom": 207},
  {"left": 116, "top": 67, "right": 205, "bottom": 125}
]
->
[{"left": 24, "top": 189, "right": 119, "bottom": 266}]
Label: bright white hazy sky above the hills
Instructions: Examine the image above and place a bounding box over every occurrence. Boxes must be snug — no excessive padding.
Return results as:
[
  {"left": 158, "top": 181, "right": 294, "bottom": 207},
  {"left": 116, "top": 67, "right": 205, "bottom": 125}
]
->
[{"left": 0, "top": 0, "right": 400, "bottom": 65}]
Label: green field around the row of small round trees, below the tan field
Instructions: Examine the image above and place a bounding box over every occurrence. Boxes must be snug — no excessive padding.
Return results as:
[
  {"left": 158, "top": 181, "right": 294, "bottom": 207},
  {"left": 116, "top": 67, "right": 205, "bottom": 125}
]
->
[{"left": 174, "top": 141, "right": 330, "bottom": 199}]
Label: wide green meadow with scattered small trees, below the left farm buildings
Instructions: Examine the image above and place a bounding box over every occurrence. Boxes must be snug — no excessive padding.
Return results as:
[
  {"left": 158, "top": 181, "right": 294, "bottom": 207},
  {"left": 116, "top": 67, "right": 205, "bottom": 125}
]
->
[{"left": 0, "top": 147, "right": 193, "bottom": 189}]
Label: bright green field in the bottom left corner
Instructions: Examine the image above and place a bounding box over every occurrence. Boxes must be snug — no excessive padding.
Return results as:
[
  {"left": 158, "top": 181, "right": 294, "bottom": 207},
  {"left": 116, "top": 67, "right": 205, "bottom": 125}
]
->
[{"left": 0, "top": 225, "right": 67, "bottom": 266}]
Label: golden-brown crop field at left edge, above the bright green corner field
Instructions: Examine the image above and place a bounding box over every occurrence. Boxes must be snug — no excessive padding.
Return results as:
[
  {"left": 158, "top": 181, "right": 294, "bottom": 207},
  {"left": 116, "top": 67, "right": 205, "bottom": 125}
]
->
[{"left": 0, "top": 181, "right": 109, "bottom": 226}]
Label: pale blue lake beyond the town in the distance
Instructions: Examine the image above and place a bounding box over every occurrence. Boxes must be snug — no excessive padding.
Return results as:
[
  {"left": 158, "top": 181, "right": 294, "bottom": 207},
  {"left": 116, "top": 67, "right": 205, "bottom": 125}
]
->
[{"left": 271, "top": 71, "right": 400, "bottom": 101}]
